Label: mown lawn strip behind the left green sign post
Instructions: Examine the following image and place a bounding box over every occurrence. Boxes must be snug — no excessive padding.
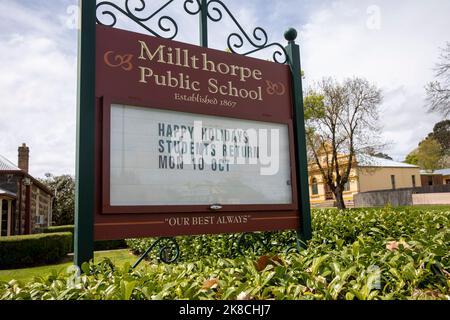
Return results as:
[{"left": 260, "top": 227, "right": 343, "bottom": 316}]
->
[{"left": 0, "top": 249, "right": 141, "bottom": 283}]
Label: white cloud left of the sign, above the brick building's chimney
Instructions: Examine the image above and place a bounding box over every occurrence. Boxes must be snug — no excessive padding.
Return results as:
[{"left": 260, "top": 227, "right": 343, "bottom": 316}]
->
[{"left": 0, "top": 3, "right": 76, "bottom": 176}]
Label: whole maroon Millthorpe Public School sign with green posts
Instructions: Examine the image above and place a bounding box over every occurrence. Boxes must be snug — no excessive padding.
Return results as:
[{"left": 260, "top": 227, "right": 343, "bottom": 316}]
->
[{"left": 75, "top": 0, "right": 311, "bottom": 264}]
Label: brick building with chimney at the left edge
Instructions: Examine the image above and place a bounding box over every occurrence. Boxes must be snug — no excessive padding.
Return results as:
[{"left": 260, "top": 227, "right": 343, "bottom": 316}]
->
[{"left": 0, "top": 144, "right": 52, "bottom": 237}]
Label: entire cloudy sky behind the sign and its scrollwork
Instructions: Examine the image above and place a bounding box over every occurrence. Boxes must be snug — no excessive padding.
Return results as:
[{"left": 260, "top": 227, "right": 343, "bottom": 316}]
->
[{"left": 0, "top": 0, "right": 450, "bottom": 176}]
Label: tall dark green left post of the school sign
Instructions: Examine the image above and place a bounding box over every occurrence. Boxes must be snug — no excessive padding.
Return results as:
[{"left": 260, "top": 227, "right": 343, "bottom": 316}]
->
[{"left": 74, "top": 0, "right": 96, "bottom": 266}]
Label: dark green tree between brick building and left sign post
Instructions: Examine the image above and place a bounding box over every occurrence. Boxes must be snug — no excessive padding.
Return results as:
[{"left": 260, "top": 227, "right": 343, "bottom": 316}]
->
[{"left": 41, "top": 174, "right": 75, "bottom": 226}]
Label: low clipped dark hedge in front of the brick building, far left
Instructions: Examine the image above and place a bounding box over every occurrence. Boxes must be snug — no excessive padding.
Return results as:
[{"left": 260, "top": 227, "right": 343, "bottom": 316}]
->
[{"left": 0, "top": 232, "right": 72, "bottom": 269}]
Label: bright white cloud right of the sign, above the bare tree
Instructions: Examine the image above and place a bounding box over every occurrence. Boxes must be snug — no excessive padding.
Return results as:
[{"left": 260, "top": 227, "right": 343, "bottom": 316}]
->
[{"left": 301, "top": 1, "right": 450, "bottom": 160}]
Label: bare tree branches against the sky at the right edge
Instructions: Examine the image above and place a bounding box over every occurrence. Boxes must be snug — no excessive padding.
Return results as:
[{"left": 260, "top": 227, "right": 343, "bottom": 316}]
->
[{"left": 425, "top": 42, "right": 450, "bottom": 117}]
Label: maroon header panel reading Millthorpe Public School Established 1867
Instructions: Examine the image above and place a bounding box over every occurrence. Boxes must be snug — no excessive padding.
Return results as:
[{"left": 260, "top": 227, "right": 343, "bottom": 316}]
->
[{"left": 97, "top": 25, "right": 291, "bottom": 121}]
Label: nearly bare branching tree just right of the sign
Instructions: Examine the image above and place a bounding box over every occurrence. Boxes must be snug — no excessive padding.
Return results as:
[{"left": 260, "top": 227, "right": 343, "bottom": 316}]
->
[{"left": 305, "top": 78, "right": 382, "bottom": 209}]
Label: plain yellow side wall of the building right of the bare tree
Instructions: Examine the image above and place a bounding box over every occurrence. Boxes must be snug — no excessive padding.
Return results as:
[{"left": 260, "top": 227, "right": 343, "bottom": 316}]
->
[{"left": 358, "top": 167, "right": 421, "bottom": 192}]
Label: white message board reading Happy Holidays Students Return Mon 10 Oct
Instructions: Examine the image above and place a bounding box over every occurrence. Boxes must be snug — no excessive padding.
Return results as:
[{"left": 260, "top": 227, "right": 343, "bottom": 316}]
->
[{"left": 110, "top": 104, "right": 292, "bottom": 206}]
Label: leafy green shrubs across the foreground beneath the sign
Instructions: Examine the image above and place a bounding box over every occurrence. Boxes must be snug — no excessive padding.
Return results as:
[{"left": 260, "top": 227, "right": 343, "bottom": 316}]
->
[{"left": 0, "top": 208, "right": 450, "bottom": 300}]
